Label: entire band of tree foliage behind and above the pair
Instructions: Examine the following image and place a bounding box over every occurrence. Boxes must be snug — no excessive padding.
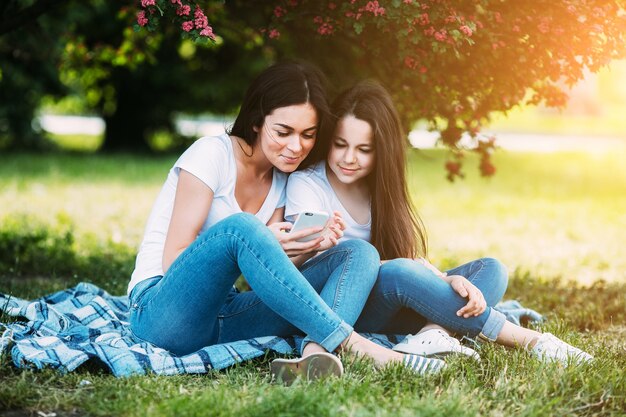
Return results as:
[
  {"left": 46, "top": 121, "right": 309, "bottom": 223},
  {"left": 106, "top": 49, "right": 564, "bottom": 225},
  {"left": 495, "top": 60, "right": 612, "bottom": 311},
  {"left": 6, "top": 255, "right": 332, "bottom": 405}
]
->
[{"left": 0, "top": 0, "right": 626, "bottom": 179}]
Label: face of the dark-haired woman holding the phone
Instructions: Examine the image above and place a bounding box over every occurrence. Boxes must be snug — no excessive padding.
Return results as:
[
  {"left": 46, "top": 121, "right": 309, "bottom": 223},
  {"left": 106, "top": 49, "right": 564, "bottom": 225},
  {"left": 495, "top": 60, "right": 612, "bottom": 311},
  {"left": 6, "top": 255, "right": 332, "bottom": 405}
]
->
[{"left": 254, "top": 103, "right": 317, "bottom": 172}]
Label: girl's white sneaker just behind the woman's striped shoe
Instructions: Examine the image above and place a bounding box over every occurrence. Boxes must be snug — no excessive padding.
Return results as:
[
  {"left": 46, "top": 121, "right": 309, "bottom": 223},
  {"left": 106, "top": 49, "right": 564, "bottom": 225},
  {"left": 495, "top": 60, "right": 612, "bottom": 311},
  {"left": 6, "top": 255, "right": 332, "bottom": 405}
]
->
[{"left": 392, "top": 329, "right": 480, "bottom": 361}]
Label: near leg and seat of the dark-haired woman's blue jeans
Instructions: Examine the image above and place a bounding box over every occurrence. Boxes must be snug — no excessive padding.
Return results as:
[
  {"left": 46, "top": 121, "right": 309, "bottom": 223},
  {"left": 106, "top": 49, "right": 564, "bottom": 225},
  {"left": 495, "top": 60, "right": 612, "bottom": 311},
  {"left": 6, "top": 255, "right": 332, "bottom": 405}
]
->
[{"left": 130, "top": 213, "right": 375, "bottom": 355}]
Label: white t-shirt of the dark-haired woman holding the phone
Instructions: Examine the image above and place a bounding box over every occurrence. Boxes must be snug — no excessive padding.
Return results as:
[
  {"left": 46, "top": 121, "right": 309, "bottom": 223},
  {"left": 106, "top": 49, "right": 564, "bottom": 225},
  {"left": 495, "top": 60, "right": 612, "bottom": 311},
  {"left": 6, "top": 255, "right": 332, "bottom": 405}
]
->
[{"left": 128, "top": 134, "right": 287, "bottom": 294}]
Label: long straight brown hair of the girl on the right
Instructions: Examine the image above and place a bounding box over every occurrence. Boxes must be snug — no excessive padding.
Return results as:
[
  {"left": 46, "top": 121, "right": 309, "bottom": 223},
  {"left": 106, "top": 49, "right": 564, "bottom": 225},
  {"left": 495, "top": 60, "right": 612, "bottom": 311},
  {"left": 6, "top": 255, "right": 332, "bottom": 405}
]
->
[{"left": 325, "top": 81, "right": 428, "bottom": 259}]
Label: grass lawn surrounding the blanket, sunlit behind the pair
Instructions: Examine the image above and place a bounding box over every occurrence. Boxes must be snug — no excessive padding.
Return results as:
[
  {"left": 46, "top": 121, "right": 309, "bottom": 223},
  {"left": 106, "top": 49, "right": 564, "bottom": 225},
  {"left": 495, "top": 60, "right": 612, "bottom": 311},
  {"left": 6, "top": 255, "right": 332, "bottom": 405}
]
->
[{"left": 0, "top": 145, "right": 626, "bottom": 417}]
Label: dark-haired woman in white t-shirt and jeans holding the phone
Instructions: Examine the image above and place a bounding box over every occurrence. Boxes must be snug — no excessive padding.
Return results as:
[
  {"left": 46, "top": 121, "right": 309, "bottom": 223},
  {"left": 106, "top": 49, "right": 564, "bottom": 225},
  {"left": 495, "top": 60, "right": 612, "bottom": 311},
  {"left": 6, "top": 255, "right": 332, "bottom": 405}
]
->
[{"left": 128, "top": 63, "right": 441, "bottom": 379}]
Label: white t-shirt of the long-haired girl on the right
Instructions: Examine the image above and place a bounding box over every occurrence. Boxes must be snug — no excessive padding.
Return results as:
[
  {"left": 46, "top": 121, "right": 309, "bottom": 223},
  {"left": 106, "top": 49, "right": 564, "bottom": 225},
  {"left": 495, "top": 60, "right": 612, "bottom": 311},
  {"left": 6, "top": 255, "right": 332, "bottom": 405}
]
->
[{"left": 285, "top": 161, "right": 372, "bottom": 242}]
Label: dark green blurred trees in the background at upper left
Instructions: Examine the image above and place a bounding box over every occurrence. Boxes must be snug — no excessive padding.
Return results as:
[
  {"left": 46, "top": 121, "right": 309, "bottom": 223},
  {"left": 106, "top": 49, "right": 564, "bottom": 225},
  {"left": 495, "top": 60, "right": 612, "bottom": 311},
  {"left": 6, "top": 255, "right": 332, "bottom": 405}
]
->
[{"left": 0, "top": 0, "right": 274, "bottom": 151}]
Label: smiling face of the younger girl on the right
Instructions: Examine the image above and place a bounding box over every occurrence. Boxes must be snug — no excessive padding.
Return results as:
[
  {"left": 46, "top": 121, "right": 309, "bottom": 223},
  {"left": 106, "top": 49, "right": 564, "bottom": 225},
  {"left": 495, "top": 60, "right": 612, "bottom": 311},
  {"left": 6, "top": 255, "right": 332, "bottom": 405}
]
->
[{"left": 328, "top": 115, "right": 376, "bottom": 184}]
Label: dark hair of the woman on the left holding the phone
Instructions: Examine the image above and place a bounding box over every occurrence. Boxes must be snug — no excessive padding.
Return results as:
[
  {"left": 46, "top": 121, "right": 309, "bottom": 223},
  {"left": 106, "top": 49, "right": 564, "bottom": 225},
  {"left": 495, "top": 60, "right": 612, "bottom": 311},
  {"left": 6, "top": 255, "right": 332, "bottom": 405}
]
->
[{"left": 228, "top": 61, "right": 330, "bottom": 164}]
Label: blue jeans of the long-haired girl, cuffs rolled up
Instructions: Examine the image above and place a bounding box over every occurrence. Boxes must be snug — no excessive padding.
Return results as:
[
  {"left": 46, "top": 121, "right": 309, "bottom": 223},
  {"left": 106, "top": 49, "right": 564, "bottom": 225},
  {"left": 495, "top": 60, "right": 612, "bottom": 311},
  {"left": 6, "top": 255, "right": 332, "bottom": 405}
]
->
[{"left": 354, "top": 258, "right": 508, "bottom": 341}]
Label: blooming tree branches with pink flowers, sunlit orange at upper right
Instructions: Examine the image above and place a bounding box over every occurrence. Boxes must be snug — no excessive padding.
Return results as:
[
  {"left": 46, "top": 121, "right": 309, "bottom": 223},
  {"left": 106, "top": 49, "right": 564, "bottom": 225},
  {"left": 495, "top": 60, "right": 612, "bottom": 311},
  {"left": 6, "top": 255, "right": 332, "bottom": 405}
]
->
[{"left": 144, "top": 0, "right": 626, "bottom": 180}]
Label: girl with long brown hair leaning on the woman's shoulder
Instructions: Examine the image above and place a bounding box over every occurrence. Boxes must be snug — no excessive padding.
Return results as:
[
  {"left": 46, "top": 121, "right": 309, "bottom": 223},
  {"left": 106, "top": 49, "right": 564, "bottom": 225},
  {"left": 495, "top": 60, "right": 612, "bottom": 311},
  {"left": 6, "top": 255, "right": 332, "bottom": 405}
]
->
[{"left": 285, "top": 83, "right": 592, "bottom": 362}]
